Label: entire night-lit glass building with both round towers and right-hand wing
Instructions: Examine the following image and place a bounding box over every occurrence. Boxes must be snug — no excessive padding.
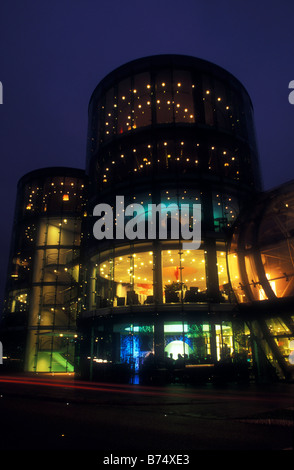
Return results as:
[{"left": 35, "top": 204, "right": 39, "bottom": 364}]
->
[{"left": 2, "top": 55, "right": 294, "bottom": 383}]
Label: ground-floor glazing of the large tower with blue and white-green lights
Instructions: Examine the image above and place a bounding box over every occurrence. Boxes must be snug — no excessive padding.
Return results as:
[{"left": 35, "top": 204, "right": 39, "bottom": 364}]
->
[{"left": 88, "top": 320, "right": 252, "bottom": 374}]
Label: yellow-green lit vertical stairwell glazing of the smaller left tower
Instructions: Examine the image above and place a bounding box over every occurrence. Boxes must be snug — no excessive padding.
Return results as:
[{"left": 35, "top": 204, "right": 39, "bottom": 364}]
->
[{"left": 18, "top": 171, "right": 84, "bottom": 372}]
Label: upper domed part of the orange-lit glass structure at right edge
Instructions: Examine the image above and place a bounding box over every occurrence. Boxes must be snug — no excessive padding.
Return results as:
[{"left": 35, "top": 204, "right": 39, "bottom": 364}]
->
[{"left": 228, "top": 180, "right": 294, "bottom": 303}]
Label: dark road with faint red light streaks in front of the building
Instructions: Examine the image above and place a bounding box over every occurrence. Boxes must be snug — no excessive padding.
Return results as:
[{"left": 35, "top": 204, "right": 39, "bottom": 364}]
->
[{"left": 0, "top": 375, "right": 294, "bottom": 463}]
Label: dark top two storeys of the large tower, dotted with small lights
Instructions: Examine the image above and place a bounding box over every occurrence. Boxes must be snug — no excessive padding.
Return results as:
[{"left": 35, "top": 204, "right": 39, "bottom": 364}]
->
[{"left": 87, "top": 56, "right": 260, "bottom": 191}]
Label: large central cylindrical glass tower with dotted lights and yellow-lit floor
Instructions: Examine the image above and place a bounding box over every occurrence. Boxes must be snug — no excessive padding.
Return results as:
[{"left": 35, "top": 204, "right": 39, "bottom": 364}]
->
[{"left": 79, "top": 55, "right": 261, "bottom": 380}]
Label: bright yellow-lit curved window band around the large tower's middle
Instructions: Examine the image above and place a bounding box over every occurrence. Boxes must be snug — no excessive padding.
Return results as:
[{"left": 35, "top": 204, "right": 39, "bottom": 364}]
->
[{"left": 89, "top": 244, "right": 231, "bottom": 310}]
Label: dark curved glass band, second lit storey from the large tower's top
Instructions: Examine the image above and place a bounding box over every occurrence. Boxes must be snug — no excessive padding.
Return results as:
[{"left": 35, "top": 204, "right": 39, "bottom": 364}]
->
[{"left": 94, "top": 137, "right": 254, "bottom": 191}]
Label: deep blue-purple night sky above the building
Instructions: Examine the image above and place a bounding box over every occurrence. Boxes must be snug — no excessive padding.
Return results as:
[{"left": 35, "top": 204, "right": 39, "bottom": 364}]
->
[{"left": 0, "top": 0, "right": 294, "bottom": 301}]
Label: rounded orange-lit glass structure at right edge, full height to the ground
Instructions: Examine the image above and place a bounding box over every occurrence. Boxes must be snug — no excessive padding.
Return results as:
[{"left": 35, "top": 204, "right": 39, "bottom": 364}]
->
[{"left": 228, "top": 182, "right": 294, "bottom": 379}]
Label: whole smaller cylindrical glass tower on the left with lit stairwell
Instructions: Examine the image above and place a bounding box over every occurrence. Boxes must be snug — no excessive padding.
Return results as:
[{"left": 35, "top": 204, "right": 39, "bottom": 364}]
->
[{"left": 2, "top": 168, "right": 84, "bottom": 372}]
